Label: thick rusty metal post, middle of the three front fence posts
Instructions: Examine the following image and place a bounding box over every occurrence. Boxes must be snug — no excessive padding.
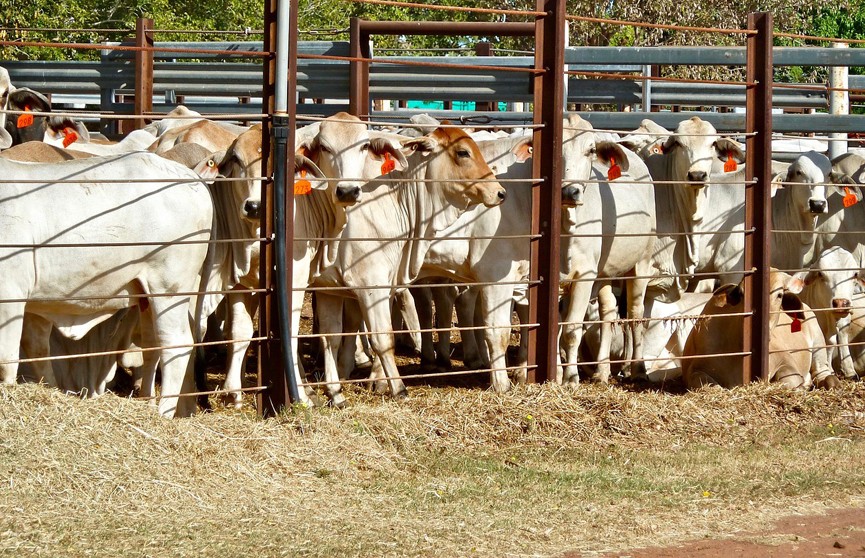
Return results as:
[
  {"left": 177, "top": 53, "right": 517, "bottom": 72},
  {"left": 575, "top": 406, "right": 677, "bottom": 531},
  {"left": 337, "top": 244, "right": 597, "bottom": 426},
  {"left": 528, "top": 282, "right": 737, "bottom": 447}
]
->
[{"left": 529, "top": 0, "right": 566, "bottom": 382}]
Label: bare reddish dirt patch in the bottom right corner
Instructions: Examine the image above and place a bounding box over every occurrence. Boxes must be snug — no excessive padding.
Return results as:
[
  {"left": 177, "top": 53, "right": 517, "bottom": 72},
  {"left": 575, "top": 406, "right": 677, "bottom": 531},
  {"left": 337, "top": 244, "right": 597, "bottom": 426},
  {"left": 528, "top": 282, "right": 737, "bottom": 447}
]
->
[{"left": 580, "top": 508, "right": 865, "bottom": 558}]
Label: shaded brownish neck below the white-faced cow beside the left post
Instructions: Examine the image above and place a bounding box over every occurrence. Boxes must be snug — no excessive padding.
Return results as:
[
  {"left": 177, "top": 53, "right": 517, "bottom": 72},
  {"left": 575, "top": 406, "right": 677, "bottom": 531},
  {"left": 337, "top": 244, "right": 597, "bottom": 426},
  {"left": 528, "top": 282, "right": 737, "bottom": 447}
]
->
[{"left": 294, "top": 190, "right": 346, "bottom": 276}]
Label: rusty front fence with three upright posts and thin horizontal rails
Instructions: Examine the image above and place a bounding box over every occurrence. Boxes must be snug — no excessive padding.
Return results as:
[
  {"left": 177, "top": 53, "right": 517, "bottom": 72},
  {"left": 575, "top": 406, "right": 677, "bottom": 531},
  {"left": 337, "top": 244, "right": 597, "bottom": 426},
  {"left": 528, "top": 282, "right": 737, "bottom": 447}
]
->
[{"left": 7, "top": 0, "right": 855, "bottom": 416}]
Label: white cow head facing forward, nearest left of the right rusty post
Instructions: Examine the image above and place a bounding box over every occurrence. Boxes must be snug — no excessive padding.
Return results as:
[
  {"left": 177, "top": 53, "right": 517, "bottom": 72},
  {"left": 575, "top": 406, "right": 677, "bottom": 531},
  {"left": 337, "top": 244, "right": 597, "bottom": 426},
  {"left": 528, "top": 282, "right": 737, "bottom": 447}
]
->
[{"left": 663, "top": 116, "right": 745, "bottom": 222}]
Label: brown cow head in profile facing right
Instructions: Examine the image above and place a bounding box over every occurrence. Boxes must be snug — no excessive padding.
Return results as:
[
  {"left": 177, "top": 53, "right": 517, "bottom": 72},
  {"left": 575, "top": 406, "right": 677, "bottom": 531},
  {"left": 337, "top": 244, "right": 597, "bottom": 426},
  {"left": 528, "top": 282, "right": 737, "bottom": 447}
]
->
[{"left": 403, "top": 128, "right": 507, "bottom": 209}]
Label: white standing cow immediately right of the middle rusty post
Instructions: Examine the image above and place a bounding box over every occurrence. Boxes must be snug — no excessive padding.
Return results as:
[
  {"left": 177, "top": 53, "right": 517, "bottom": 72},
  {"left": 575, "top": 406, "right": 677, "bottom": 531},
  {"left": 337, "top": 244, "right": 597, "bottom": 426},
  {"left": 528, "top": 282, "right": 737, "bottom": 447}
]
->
[{"left": 559, "top": 115, "right": 656, "bottom": 383}]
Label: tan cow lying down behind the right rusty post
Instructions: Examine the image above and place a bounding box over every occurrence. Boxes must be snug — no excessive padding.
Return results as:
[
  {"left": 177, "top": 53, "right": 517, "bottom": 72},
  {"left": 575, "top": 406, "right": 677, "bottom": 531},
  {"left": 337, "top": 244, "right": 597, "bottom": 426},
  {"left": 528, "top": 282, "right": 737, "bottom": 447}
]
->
[{"left": 682, "top": 269, "right": 838, "bottom": 389}]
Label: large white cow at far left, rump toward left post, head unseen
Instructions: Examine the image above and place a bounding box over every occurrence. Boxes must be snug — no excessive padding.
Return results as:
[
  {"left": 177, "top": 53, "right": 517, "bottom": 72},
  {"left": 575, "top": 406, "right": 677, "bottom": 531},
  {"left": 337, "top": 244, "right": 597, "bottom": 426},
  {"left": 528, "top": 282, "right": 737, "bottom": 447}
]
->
[{"left": 0, "top": 154, "right": 213, "bottom": 416}]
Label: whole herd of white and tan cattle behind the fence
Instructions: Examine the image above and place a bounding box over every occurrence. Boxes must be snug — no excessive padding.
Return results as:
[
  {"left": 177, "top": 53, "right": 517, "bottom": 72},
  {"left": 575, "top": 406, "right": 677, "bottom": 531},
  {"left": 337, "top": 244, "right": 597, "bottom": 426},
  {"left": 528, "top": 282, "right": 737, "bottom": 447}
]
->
[{"left": 0, "top": 62, "right": 865, "bottom": 416}]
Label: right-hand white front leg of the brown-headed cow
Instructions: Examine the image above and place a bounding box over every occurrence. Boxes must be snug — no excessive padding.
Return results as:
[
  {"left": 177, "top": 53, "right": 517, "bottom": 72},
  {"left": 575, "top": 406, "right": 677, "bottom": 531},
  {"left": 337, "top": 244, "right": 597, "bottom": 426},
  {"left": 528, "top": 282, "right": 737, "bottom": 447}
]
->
[{"left": 357, "top": 286, "right": 408, "bottom": 398}]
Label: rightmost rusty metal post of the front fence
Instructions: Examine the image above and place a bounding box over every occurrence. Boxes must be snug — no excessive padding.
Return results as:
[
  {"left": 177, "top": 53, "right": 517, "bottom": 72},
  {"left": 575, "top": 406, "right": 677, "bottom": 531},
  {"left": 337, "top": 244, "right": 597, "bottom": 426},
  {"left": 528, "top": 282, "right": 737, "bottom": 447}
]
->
[{"left": 742, "top": 12, "right": 773, "bottom": 383}]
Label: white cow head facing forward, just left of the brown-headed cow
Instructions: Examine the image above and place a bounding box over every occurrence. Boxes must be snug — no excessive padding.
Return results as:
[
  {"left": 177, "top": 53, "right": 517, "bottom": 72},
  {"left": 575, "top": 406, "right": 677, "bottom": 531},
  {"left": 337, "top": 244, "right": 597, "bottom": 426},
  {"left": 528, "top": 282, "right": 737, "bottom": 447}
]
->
[{"left": 296, "top": 112, "right": 407, "bottom": 206}]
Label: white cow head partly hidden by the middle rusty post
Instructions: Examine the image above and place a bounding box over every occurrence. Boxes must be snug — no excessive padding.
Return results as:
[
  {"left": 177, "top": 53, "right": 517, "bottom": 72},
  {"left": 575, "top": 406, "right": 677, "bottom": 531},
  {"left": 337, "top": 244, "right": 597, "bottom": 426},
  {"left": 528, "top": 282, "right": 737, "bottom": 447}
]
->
[{"left": 562, "top": 114, "right": 628, "bottom": 207}]
